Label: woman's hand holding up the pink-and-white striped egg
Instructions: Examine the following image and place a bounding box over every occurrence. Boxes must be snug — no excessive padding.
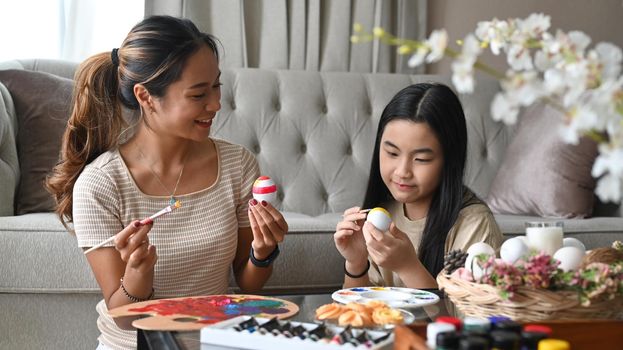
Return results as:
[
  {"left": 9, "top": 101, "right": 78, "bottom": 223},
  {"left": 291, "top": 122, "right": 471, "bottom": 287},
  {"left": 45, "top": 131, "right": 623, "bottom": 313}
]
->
[{"left": 249, "top": 199, "right": 288, "bottom": 260}]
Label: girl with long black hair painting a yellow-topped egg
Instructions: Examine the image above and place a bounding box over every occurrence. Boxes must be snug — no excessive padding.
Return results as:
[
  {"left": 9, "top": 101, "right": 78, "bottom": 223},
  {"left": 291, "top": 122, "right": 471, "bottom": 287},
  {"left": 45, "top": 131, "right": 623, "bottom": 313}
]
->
[{"left": 334, "top": 84, "right": 502, "bottom": 288}]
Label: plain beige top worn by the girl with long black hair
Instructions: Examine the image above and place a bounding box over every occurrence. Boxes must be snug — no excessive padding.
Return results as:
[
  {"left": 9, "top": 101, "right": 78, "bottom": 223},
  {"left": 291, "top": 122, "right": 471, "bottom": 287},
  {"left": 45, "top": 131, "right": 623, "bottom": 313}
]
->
[{"left": 368, "top": 196, "right": 503, "bottom": 287}]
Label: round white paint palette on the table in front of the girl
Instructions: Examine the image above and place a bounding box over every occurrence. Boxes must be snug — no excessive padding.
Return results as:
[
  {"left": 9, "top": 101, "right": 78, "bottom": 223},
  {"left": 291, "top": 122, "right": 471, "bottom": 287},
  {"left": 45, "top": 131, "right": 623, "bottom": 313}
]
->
[{"left": 331, "top": 287, "right": 439, "bottom": 308}]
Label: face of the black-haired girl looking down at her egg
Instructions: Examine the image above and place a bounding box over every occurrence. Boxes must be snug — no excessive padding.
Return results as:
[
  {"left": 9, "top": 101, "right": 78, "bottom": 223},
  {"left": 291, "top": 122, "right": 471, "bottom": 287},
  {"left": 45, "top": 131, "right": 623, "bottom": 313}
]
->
[{"left": 379, "top": 119, "right": 443, "bottom": 219}]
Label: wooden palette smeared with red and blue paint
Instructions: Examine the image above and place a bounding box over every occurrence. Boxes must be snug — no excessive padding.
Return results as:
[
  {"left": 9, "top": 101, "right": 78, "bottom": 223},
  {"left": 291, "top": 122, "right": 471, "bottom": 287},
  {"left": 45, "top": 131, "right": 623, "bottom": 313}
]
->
[{"left": 108, "top": 294, "right": 299, "bottom": 331}]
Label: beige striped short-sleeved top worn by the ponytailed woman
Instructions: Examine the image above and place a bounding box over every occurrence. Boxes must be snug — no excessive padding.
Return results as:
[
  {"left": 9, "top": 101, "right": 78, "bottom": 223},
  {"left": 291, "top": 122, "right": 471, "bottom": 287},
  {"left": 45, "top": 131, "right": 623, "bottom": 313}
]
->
[{"left": 73, "top": 139, "right": 259, "bottom": 349}]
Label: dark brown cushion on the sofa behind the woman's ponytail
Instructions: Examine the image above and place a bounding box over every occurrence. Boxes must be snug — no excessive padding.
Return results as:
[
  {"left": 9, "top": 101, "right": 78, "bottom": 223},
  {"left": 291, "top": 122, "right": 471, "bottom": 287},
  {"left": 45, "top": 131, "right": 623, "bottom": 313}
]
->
[{"left": 0, "top": 70, "right": 73, "bottom": 215}]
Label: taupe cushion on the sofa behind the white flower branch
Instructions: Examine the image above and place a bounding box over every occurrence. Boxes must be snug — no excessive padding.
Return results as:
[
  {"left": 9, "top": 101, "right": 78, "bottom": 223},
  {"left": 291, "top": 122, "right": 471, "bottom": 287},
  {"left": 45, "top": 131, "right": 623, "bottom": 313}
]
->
[{"left": 487, "top": 104, "right": 597, "bottom": 218}]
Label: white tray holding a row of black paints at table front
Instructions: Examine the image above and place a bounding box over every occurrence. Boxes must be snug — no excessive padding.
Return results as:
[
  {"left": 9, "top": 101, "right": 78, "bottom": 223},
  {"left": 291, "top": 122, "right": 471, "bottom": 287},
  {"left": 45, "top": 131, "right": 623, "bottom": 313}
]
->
[{"left": 201, "top": 316, "right": 394, "bottom": 350}]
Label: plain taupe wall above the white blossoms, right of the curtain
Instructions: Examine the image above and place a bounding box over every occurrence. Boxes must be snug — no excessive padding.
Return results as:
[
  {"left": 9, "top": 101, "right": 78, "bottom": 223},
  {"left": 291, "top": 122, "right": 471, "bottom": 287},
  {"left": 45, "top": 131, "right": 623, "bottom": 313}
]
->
[{"left": 427, "top": 0, "right": 623, "bottom": 73}]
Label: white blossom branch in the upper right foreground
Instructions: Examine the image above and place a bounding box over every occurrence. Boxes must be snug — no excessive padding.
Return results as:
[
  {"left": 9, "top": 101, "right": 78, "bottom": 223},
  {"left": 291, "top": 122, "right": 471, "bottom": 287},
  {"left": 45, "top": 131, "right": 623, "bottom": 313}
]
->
[{"left": 351, "top": 14, "right": 623, "bottom": 202}]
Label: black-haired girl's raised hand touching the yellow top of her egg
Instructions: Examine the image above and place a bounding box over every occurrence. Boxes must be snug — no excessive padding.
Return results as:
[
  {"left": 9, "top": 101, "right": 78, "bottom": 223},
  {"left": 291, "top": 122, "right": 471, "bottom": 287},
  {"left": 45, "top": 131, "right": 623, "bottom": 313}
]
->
[{"left": 333, "top": 207, "right": 368, "bottom": 266}]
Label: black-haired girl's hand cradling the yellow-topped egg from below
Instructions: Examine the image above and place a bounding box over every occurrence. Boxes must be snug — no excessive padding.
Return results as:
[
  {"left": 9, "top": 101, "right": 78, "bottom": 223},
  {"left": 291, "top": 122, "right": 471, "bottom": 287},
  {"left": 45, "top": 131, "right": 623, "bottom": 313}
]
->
[{"left": 363, "top": 221, "right": 418, "bottom": 272}]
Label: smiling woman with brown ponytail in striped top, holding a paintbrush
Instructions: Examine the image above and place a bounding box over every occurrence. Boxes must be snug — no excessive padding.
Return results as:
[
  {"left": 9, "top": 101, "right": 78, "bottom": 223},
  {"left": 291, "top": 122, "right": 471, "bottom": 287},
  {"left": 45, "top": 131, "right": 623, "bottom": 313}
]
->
[{"left": 48, "top": 16, "right": 288, "bottom": 349}]
